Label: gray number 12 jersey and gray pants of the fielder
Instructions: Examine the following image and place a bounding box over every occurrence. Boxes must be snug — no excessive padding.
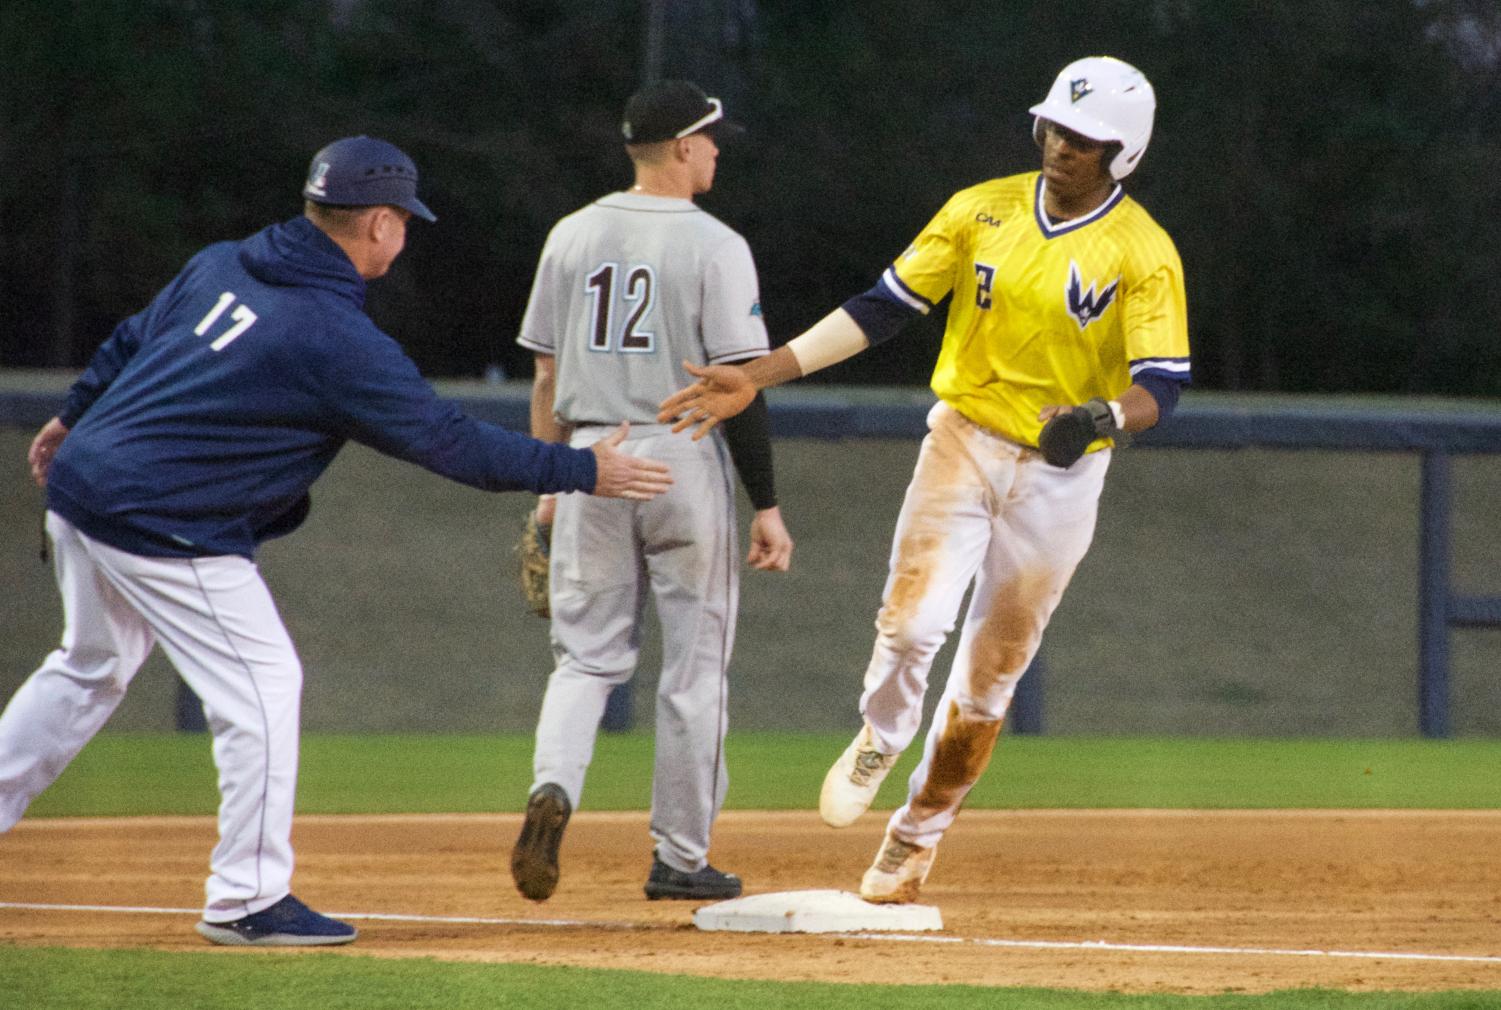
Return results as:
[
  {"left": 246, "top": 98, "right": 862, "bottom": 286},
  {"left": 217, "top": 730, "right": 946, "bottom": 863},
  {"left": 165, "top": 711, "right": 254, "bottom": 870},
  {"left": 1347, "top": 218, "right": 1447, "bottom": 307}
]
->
[{"left": 518, "top": 194, "right": 767, "bottom": 872}]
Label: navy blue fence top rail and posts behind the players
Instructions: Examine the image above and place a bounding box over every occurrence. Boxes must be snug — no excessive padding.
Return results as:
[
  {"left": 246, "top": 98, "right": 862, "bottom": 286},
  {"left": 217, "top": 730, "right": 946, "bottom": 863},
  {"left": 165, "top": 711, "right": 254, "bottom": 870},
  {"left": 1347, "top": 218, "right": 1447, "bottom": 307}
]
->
[{"left": 0, "top": 372, "right": 1501, "bottom": 737}]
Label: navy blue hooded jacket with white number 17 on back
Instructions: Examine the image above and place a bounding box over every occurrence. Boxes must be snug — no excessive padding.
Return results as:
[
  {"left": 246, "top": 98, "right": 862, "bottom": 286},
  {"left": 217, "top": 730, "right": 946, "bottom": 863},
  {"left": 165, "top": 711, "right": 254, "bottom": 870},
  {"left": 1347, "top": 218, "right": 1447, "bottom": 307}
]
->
[{"left": 47, "top": 218, "right": 596, "bottom": 557}]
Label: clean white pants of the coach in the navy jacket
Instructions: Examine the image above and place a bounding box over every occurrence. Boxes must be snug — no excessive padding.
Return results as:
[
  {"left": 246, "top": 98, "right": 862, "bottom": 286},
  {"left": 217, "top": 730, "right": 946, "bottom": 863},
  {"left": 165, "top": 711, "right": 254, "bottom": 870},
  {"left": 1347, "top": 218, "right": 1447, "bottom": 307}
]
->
[{"left": 0, "top": 513, "right": 302, "bottom": 921}]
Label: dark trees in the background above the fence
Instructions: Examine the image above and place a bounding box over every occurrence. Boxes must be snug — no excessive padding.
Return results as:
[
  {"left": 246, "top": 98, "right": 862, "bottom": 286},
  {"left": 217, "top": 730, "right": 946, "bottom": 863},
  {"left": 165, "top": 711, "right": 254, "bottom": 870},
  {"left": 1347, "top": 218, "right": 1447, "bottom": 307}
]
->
[{"left": 0, "top": 0, "right": 1501, "bottom": 396}]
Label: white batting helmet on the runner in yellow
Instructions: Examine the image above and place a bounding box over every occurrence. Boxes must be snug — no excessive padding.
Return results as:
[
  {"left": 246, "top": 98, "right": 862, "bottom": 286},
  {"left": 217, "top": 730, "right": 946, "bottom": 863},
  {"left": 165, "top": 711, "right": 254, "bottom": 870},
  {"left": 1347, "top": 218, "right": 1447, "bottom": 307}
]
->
[{"left": 1027, "top": 56, "right": 1157, "bottom": 179}]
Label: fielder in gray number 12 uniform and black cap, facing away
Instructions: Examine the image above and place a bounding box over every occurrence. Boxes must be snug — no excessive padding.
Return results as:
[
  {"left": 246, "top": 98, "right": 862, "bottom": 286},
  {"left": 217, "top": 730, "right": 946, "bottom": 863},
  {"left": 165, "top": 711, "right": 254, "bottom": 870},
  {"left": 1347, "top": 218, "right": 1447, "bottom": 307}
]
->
[{"left": 510, "top": 81, "right": 793, "bottom": 900}]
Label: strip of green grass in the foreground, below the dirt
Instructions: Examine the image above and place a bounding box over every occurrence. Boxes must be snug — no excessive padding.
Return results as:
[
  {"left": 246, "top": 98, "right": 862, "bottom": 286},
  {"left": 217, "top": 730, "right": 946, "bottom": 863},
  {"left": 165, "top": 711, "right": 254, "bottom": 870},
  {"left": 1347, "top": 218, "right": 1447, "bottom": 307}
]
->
[{"left": 0, "top": 947, "right": 1501, "bottom": 1010}]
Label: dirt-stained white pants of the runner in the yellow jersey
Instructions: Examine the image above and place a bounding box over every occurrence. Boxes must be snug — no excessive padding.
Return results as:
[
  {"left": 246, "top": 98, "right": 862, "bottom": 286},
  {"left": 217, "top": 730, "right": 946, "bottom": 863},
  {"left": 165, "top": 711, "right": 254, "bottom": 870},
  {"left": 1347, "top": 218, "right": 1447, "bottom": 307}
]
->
[{"left": 860, "top": 402, "right": 1111, "bottom": 846}]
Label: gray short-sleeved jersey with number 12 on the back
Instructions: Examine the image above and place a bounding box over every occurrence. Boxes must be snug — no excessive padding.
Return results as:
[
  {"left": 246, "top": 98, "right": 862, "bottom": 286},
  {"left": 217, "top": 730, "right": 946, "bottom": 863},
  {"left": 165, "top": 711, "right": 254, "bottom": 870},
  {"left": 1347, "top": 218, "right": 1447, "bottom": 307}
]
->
[{"left": 516, "top": 192, "right": 767, "bottom": 425}]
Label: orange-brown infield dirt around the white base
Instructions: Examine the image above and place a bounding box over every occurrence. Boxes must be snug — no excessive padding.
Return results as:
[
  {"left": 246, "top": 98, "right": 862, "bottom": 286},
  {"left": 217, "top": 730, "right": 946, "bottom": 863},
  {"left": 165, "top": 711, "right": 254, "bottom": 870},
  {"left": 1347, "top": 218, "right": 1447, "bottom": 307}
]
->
[{"left": 0, "top": 810, "right": 1501, "bottom": 993}]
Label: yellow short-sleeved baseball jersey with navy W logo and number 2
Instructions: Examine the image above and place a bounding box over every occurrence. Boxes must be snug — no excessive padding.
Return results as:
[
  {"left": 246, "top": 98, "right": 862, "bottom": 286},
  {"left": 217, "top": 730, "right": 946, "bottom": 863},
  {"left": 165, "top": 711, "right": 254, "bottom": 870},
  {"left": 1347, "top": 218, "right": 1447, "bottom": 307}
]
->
[{"left": 880, "top": 173, "right": 1189, "bottom": 450}]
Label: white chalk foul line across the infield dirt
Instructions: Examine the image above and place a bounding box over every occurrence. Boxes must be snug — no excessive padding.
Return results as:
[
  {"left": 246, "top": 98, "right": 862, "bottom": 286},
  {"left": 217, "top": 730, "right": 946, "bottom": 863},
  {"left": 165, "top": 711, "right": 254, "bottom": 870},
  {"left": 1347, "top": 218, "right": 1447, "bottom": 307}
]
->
[{"left": 0, "top": 902, "right": 1501, "bottom": 965}]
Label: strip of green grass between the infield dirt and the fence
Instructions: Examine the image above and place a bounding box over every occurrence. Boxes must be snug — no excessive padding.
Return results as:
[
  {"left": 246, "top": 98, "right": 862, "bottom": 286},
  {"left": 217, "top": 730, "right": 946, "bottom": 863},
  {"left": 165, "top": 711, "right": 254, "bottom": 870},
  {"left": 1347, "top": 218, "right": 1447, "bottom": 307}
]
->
[{"left": 20, "top": 732, "right": 1501, "bottom": 816}]
